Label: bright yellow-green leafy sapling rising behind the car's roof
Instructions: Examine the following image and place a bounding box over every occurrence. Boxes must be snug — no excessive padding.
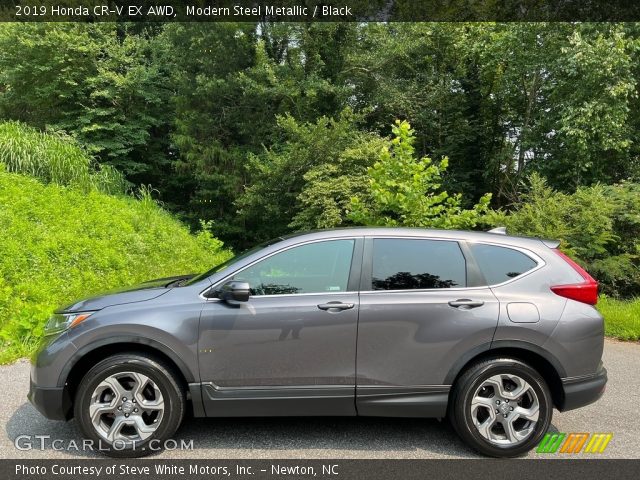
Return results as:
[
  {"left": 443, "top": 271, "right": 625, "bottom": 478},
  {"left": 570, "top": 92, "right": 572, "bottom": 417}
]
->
[{"left": 350, "top": 120, "right": 491, "bottom": 228}]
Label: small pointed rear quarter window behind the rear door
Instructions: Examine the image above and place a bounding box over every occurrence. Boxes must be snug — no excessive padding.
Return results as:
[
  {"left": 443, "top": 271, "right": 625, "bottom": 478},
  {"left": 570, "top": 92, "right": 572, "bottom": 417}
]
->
[{"left": 469, "top": 243, "right": 538, "bottom": 285}]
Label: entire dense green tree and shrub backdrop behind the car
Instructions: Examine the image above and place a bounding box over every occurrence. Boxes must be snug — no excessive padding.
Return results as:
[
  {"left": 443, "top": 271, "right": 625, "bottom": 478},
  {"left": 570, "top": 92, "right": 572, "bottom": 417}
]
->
[{"left": 0, "top": 22, "right": 640, "bottom": 296}]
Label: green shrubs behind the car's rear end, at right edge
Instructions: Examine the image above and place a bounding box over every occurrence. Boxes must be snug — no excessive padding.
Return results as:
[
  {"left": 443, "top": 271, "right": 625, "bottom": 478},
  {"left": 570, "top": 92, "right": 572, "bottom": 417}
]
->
[{"left": 488, "top": 175, "right": 640, "bottom": 297}]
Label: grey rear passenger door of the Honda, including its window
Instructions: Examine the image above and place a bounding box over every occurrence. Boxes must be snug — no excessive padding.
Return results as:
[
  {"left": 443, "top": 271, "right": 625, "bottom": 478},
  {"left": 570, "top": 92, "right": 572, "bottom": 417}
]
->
[{"left": 356, "top": 237, "right": 499, "bottom": 416}]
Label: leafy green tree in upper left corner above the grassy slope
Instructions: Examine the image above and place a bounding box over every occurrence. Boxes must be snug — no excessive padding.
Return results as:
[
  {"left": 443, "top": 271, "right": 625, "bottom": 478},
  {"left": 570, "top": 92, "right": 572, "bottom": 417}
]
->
[{"left": 0, "top": 22, "right": 170, "bottom": 185}]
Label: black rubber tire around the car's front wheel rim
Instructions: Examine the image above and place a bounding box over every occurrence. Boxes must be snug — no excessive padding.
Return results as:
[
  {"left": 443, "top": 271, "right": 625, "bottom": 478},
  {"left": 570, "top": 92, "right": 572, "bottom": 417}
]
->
[{"left": 74, "top": 353, "right": 186, "bottom": 458}]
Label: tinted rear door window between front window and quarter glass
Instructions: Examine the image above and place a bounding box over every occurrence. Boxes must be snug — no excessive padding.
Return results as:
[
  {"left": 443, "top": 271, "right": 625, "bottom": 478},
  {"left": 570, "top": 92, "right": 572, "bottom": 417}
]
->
[{"left": 372, "top": 239, "right": 466, "bottom": 290}]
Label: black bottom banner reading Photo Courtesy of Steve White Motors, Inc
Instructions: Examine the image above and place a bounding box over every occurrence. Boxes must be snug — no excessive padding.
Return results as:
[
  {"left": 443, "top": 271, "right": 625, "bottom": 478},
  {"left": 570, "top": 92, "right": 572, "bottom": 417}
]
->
[{"left": 0, "top": 459, "right": 640, "bottom": 480}]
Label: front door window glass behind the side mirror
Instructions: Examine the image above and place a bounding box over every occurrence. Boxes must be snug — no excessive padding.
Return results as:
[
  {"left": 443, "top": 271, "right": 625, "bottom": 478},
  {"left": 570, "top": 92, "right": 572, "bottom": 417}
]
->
[{"left": 233, "top": 240, "right": 354, "bottom": 295}]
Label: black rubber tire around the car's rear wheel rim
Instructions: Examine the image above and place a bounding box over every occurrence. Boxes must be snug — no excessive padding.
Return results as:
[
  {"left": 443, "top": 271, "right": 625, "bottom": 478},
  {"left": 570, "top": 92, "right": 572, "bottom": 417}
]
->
[{"left": 449, "top": 358, "right": 553, "bottom": 457}]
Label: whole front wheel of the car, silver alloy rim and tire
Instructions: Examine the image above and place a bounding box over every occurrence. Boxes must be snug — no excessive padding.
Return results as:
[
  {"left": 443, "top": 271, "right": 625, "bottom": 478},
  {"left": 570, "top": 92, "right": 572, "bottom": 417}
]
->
[{"left": 74, "top": 353, "right": 185, "bottom": 457}]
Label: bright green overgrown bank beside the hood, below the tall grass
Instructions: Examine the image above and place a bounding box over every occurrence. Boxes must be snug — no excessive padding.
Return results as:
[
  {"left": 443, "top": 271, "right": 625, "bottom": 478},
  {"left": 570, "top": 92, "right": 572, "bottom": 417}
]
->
[{"left": 0, "top": 171, "right": 229, "bottom": 362}]
